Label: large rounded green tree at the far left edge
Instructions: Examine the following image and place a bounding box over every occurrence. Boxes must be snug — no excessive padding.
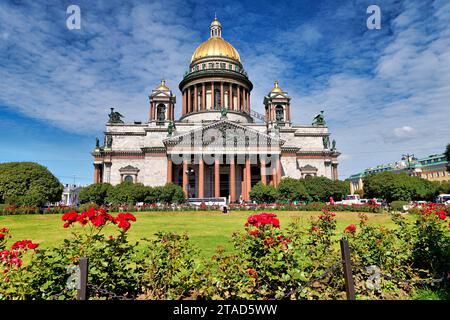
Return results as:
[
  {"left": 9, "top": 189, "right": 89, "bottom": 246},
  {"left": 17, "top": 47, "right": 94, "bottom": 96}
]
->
[{"left": 0, "top": 162, "right": 64, "bottom": 206}]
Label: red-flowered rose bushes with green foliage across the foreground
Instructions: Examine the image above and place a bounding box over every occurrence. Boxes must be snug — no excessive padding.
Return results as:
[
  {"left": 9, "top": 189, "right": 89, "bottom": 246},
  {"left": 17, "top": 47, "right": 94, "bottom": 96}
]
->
[{"left": 0, "top": 205, "right": 450, "bottom": 299}]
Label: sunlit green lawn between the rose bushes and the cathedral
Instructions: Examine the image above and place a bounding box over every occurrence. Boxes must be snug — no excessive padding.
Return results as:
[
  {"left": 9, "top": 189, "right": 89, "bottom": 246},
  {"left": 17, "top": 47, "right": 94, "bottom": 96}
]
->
[{"left": 0, "top": 211, "right": 400, "bottom": 256}]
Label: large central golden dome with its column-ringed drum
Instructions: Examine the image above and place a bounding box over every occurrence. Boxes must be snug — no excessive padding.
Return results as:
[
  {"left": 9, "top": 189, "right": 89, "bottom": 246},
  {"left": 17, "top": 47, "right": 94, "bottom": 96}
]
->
[{"left": 179, "top": 19, "right": 253, "bottom": 122}]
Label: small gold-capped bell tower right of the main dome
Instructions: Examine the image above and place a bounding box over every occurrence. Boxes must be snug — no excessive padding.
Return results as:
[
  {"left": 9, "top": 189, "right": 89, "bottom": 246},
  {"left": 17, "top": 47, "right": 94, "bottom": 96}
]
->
[{"left": 264, "top": 81, "right": 291, "bottom": 126}]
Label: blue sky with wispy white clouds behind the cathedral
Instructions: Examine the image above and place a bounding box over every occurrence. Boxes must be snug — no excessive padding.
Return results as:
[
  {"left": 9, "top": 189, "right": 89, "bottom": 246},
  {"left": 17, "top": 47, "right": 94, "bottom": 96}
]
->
[{"left": 0, "top": 0, "right": 450, "bottom": 184}]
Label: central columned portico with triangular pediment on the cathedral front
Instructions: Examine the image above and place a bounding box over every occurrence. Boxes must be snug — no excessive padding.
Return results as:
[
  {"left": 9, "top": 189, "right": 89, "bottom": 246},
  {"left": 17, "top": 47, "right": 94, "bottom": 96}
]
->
[{"left": 163, "top": 120, "right": 283, "bottom": 201}]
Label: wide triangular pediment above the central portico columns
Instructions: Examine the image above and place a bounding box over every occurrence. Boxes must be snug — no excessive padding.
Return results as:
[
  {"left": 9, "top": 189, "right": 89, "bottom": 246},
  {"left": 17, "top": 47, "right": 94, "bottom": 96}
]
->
[{"left": 163, "top": 119, "right": 284, "bottom": 148}]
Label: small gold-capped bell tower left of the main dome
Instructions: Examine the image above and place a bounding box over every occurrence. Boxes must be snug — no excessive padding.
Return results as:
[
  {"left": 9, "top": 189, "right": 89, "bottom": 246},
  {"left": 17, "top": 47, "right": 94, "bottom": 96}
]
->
[{"left": 149, "top": 80, "right": 176, "bottom": 123}]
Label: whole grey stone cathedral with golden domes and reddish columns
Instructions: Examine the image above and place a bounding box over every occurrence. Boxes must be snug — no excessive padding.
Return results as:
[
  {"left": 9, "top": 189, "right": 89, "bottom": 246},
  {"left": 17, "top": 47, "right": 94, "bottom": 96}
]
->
[{"left": 92, "top": 19, "right": 340, "bottom": 202}]
